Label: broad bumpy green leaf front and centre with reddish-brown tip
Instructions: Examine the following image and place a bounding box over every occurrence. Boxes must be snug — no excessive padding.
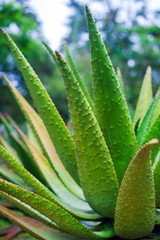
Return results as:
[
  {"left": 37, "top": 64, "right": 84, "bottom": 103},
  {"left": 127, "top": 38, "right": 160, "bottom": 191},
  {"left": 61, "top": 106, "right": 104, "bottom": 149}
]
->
[{"left": 56, "top": 52, "right": 118, "bottom": 217}]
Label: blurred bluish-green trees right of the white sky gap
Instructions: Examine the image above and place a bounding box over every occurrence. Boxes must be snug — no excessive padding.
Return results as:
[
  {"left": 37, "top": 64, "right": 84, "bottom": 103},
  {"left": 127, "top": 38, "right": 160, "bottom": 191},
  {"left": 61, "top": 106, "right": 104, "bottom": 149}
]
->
[{"left": 65, "top": 0, "right": 160, "bottom": 113}]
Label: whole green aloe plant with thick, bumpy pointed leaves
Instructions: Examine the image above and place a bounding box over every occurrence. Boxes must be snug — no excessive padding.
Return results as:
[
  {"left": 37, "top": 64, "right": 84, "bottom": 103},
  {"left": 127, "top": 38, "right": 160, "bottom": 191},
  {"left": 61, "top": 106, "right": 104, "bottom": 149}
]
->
[{"left": 0, "top": 7, "right": 160, "bottom": 240}]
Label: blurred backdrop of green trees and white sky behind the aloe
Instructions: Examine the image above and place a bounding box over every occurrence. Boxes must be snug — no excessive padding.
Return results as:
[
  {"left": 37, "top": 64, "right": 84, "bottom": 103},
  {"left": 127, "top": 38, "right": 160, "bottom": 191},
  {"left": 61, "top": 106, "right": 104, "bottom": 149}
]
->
[{"left": 0, "top": 0, "right": 160, "bottom": 123}]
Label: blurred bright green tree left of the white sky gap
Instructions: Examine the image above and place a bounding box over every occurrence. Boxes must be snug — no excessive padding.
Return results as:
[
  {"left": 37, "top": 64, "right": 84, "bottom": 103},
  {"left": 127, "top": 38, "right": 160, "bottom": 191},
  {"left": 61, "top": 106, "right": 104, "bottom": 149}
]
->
[{"left": 0, "top": 0, "right": 54, "bottom": 120}]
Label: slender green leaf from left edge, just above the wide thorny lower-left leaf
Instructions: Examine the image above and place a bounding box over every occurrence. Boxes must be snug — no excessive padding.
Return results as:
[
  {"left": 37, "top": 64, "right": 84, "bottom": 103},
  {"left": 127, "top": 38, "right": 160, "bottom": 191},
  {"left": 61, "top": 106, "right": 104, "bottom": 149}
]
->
[{"left": 0, "top": 143, "right": 100, "bottom": 219}]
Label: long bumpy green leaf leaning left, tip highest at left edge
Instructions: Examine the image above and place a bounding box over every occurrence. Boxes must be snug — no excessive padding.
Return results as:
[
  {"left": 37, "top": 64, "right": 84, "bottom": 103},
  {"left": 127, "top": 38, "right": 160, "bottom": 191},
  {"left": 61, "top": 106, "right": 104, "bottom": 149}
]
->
[{"left": 0, "top": 28, "right": 79, "bottom": 186}]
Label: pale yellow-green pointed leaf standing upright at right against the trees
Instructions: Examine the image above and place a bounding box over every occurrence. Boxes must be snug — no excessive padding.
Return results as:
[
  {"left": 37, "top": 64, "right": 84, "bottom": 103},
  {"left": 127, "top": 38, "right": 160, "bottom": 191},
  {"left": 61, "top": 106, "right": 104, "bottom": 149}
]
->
[{"left": 133, "top": 66, "right": 153, "bottom": 125}]
